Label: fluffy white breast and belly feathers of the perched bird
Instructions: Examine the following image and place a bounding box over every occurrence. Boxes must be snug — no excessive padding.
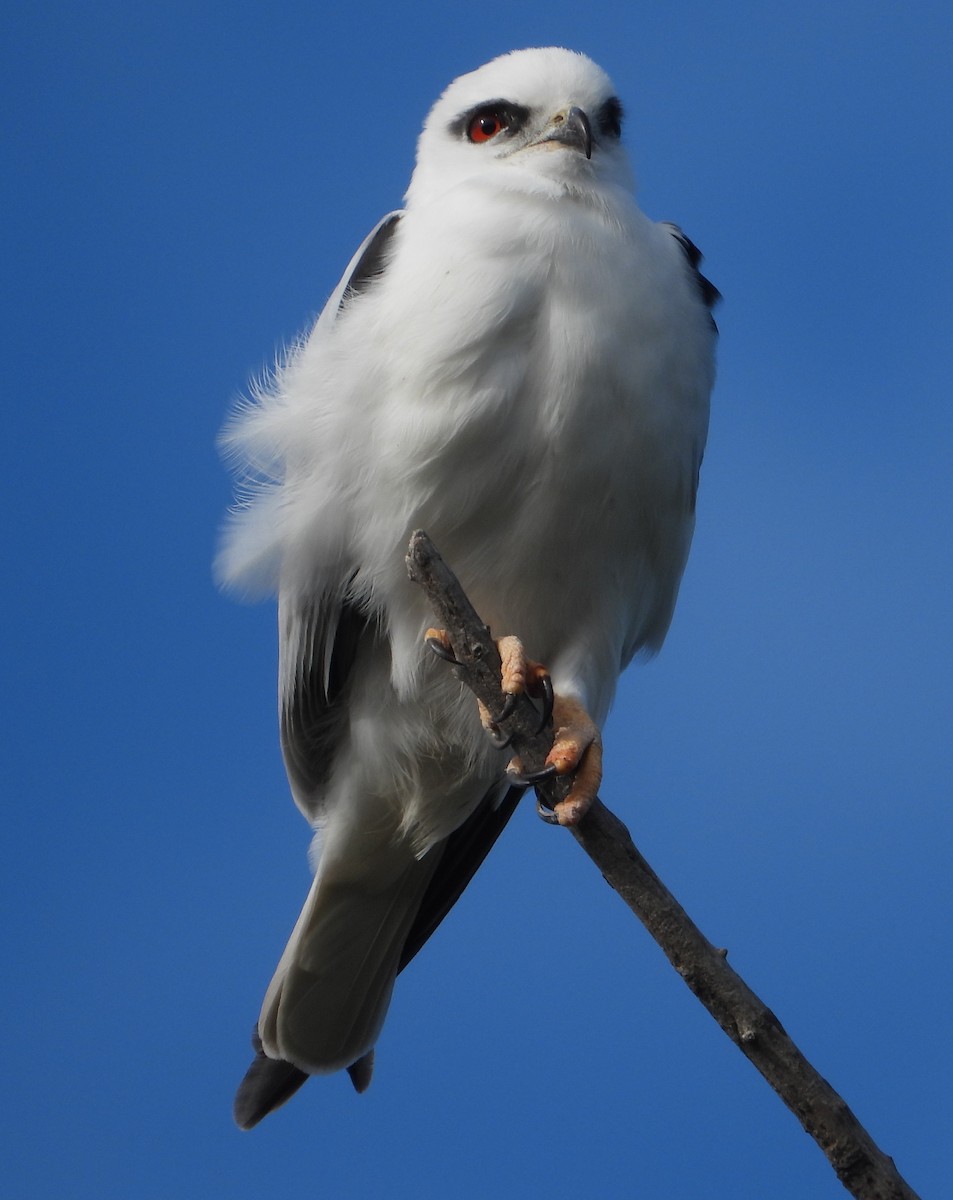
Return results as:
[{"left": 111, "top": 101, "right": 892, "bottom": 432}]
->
[{"left": 223, "top": 177, "right": 712, "bottom": 718}]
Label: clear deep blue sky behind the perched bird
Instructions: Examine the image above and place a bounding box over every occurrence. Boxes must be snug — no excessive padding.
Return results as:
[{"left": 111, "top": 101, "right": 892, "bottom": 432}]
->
[{"left": 0, "top": 0, "right": 953, "bottom": 1200}]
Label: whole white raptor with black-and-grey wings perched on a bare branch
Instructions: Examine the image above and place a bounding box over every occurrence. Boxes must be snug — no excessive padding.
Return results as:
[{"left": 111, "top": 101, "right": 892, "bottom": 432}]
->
[{"left": 216, "top": 47, "right": 719, "bottom": 1128}]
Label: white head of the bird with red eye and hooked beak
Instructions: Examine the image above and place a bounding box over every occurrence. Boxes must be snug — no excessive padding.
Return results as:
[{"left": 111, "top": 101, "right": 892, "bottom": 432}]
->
[{"left": 407, "top": 48, "right": 634, "bottom": 208}]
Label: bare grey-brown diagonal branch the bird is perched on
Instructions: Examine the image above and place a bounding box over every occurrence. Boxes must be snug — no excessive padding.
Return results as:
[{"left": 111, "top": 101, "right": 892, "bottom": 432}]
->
[{"left": 407, "top": 530, "right": 917, "bottom": 1200}]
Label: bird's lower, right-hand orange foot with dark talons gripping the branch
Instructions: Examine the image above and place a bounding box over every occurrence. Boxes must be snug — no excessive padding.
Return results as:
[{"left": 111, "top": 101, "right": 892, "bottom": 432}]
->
[{"left": 507, "top": 694, "right": 603, "bottom": 826}]
